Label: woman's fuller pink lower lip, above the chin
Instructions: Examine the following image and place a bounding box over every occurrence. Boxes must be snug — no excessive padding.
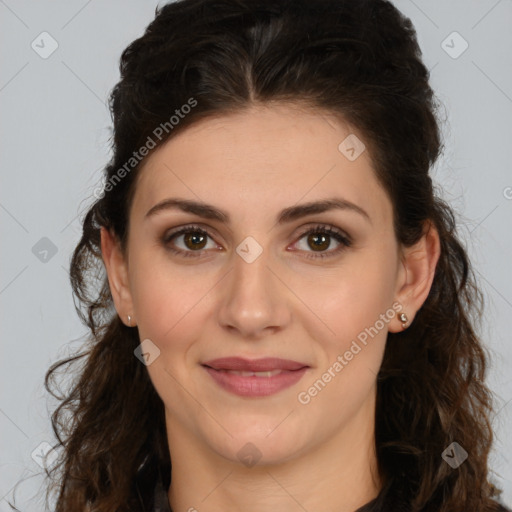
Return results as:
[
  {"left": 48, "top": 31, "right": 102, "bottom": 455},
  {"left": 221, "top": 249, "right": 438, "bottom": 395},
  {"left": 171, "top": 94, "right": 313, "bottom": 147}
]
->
[{"left": 204, "top": 366, "right": 308, "bottom": 396}]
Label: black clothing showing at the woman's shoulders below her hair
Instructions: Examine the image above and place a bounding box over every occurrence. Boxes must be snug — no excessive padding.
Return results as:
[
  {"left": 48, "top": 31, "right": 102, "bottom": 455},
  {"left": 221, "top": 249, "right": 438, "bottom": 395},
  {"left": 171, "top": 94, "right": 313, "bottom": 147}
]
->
[{"left": 137, "top": 460, "right": 512, "bottom": 512}]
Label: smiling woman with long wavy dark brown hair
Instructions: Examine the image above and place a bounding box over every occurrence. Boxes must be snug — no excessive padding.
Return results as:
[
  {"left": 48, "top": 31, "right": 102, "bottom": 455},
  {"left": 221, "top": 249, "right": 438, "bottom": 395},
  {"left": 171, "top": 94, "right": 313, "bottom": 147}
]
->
[{"left": 27, "top": 0, "right": 506, "bottom": 512}]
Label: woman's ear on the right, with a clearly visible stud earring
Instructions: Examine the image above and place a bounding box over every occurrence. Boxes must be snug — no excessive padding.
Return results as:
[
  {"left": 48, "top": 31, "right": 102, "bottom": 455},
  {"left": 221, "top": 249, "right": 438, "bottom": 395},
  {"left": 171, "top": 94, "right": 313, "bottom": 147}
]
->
[{"left": 389, "top": 221, "right": 441, "bottom": 332}]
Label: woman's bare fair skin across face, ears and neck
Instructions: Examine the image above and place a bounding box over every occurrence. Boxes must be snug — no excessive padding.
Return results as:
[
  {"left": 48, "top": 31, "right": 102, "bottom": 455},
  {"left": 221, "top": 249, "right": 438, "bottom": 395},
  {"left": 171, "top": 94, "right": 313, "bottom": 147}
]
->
[{"left": 102, "top": 104, "right": 439, "bottom": 512}]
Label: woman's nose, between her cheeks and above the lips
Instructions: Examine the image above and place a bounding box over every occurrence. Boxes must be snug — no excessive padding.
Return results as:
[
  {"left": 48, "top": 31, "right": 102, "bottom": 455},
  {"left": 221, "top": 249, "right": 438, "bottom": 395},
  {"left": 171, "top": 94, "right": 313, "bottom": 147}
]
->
[{"left": 218, "top": 244, "right": 291, "bottom": 339}]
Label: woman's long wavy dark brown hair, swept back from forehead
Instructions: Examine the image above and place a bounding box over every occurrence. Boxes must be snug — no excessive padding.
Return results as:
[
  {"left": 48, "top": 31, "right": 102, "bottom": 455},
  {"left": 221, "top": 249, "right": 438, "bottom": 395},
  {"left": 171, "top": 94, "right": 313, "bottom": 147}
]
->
[{"left": 9, "top": 0, "right": 508, "bottom": 512}]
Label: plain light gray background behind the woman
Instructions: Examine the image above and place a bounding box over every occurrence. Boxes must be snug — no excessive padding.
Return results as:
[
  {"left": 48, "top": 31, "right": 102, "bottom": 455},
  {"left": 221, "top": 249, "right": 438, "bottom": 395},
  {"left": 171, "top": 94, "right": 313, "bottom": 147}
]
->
[{"left": 0, "top": 0, "right": 512, "bottom": 512}]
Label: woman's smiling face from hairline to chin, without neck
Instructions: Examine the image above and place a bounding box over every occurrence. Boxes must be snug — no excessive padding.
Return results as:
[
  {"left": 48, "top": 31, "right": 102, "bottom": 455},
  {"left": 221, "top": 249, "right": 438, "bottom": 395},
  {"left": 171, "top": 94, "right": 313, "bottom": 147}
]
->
[{"left": 106, "top": 105, "right": 414, "bottom": 468}]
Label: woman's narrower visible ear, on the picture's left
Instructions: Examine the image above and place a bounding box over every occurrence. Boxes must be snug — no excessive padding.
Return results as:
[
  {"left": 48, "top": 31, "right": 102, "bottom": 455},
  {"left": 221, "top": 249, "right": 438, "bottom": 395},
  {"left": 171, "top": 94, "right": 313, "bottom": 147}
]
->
[{"left": 101, "top": 227, "right": 135, "bottom": 327}]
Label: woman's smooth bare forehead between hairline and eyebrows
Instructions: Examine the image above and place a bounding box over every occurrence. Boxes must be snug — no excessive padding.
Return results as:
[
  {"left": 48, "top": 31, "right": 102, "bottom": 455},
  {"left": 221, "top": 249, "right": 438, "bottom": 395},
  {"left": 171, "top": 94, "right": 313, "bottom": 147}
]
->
[{"left": 133, "top": 105, "right": 391, "bottom": 225}]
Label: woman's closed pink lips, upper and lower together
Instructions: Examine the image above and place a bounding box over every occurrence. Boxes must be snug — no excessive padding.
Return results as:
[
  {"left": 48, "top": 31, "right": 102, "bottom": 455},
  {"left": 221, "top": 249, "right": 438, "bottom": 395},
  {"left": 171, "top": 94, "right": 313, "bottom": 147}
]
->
[{"left": 203, "top": 357, "right": 308, "bottom": 397}]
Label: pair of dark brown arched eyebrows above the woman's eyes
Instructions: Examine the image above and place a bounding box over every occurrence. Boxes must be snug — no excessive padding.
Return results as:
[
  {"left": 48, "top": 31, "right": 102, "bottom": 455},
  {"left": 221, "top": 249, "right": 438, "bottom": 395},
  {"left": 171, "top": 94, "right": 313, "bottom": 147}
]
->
[{"left": 146, "top": 197, "right": 371, "bottom": 224}]
